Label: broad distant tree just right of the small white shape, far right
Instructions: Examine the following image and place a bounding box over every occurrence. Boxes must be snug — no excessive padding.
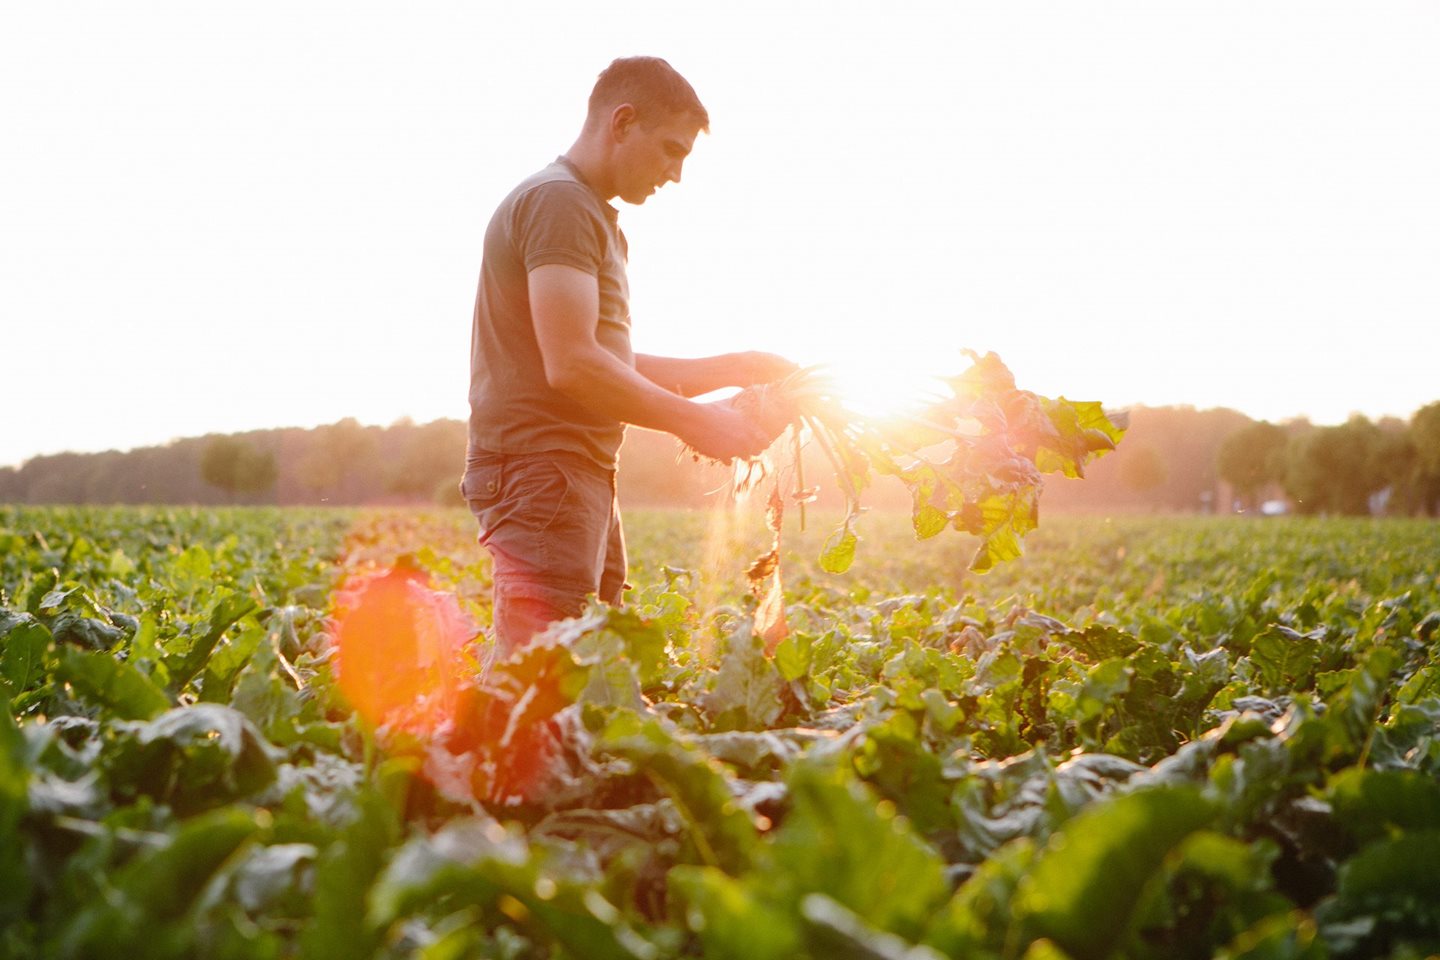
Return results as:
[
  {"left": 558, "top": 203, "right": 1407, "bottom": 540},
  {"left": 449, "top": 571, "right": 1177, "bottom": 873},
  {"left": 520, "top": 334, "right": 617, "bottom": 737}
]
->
[{"left": 1284, "top": 416, "right": 1384, "bottom": 515}]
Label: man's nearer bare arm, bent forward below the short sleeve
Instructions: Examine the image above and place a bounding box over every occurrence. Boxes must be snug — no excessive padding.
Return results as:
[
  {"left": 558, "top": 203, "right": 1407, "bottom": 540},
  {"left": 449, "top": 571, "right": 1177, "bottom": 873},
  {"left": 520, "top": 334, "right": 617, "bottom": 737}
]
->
[{"left": 528, "top": 263, "right": 770, "bottom": 461}]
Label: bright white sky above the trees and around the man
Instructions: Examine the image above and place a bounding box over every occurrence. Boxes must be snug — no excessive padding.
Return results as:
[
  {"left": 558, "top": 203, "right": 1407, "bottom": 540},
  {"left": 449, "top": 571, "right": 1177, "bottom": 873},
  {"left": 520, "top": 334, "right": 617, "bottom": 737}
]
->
[{"left": 0, "top": 0, "right": 1440, "bottom": 465}]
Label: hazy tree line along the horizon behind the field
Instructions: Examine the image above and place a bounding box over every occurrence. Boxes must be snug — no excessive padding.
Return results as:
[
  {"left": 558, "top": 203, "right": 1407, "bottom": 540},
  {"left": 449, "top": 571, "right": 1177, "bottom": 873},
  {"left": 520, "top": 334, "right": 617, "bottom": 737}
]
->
[{"left": 0, "top": 402, "right": 1440, "bottom": 515}]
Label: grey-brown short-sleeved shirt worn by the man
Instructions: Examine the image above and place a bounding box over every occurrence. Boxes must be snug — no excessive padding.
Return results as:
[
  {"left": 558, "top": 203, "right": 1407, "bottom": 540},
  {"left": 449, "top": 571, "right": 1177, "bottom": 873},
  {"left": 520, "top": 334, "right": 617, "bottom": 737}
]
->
[{"left": 469, "top": 157, "right": 635, "bottom": 469}]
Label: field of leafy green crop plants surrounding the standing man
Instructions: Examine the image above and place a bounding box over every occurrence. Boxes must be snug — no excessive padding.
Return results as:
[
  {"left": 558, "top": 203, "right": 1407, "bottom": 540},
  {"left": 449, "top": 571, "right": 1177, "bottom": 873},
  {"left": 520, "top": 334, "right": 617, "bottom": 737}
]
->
[{"left": 0, "top": 507, "right": 1440, "bottom": 960}]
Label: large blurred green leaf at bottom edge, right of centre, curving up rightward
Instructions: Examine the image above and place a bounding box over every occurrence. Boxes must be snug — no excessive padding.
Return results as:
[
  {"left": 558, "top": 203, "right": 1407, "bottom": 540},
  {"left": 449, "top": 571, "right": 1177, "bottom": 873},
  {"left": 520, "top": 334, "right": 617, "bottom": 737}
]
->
[{"left": 1017, "top": 787, "right": 1215, "bottom": 960}]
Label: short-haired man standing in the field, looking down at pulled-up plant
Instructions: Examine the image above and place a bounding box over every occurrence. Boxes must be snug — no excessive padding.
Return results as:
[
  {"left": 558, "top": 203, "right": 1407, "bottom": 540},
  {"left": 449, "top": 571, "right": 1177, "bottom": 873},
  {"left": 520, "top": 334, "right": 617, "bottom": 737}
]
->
[{"left": 461, "top": 58, "right": 795, "bottom": 653}]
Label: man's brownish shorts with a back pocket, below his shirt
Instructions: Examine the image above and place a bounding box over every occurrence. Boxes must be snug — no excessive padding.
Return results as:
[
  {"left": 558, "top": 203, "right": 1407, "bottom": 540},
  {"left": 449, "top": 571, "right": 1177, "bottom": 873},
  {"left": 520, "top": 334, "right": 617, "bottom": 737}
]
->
[{"left": 461, "top": 450, "right": 625, "bottom": 656}]
